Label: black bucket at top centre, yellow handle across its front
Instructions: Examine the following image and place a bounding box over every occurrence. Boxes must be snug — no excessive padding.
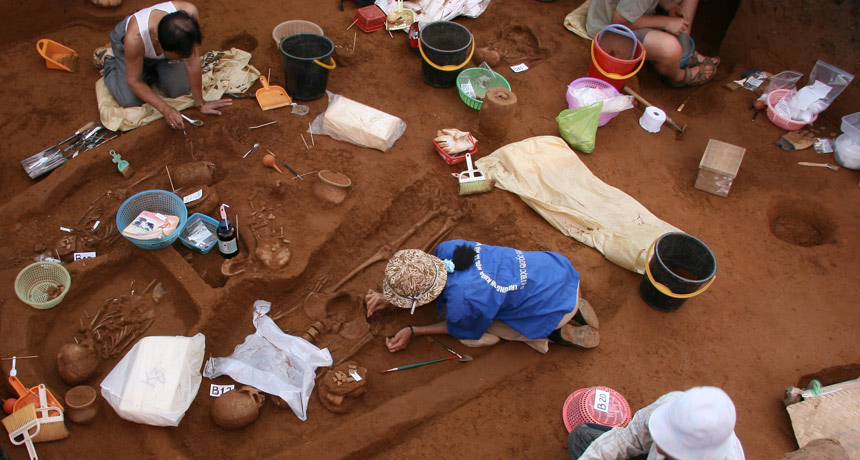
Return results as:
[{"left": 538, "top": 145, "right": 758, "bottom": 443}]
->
[{"left": 418, "top": 21, "right": 475, "bottom": 88}]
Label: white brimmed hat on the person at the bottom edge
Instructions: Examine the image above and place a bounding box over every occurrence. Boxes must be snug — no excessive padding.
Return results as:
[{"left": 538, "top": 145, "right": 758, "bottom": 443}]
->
[{"left": 648, "top": 387, "right": 736, "bottom": 460}]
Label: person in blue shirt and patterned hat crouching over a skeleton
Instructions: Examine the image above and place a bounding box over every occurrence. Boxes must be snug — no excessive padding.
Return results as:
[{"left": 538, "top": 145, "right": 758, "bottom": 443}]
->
[{"left": 366, "top": 240, "right": 600, "bottom": 353}]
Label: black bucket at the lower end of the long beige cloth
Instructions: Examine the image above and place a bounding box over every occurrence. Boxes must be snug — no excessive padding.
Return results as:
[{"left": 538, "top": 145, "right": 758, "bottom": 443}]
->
[{"left": 639, "top": 232, "right": 717, "bottom": 311}]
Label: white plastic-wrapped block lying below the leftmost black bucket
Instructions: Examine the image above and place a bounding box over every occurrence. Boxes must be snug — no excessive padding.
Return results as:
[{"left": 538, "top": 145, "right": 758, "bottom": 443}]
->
[{"left": 309, "top": 91, "right": 406, "bottom": 152}]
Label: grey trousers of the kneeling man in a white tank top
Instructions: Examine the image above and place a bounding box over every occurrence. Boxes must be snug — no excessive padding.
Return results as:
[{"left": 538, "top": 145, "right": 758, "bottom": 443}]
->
[{"left": 102, "top": 17, "right": 191, "bottom": 107}]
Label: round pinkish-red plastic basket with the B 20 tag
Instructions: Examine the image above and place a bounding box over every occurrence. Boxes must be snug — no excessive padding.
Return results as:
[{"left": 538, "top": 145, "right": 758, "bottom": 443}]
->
[{"left": 561, "top": 387, "right": 633, "bottom": 433}]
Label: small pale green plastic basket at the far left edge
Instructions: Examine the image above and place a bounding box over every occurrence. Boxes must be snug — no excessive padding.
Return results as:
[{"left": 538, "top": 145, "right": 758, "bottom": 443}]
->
[{"left": 15, "top": 262, "right": 72, "bottom": 310}]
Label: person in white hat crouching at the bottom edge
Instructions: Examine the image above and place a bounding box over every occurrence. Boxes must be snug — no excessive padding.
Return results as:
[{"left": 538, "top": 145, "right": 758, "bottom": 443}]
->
[{"left": 568, "top": 387, "right": 745, "bottom": 460}]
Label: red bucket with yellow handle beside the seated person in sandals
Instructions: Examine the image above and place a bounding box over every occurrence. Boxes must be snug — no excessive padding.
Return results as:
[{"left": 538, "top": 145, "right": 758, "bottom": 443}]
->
[{"left": 588, "top": 24, "right": 645, "bottom": 91}]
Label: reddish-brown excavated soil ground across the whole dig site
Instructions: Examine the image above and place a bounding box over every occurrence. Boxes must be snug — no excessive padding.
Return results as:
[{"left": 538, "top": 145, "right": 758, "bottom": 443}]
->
[{"left": 0, "top": 0, "right": 860, "bottom": 459}]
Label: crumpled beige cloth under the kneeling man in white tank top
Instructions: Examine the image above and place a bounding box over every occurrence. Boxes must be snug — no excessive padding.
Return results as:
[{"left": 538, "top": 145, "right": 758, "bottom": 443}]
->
[{"left": 96, "top": 48, "right": 260, "bottom": 131}]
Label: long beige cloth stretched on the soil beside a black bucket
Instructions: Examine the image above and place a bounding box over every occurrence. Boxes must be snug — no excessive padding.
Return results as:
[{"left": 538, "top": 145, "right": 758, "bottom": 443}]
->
[{"left": 476, "top": 136, "right": 681, "bottom": 273}]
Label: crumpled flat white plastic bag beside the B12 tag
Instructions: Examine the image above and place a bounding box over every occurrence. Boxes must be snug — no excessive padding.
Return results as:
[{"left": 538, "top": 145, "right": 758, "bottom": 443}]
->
[{"left": 203, "top": 300, "right": 332, "bottom": 421}]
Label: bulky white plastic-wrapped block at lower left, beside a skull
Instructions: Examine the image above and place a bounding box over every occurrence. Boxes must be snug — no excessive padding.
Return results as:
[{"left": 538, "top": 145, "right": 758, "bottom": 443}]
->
[{"left": 101, "top": 334, "right": 206, "bottom": 426}]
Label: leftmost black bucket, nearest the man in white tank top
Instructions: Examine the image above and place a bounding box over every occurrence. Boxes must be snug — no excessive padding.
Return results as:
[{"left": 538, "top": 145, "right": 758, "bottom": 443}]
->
[{"left": 278, "top": 34, "right": 335, "bottom": 101}]
